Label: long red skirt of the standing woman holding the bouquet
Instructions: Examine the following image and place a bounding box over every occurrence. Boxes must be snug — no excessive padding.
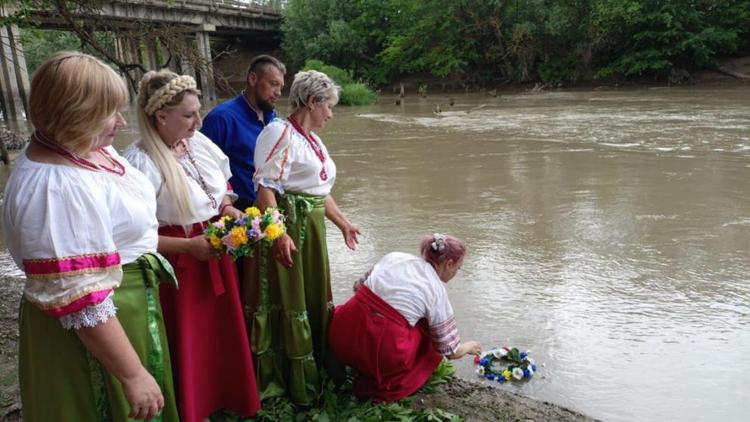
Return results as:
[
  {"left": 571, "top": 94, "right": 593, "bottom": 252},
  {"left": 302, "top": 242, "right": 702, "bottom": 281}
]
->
[{"left": 159, "top": 224, "right": 260, "bottom": 422}]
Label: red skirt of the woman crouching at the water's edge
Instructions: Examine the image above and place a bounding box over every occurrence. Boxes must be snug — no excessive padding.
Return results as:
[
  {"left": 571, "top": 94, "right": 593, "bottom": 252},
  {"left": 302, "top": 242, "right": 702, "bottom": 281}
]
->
[{"left": 328, "top": 286, "right": 443, "bottom": 401}]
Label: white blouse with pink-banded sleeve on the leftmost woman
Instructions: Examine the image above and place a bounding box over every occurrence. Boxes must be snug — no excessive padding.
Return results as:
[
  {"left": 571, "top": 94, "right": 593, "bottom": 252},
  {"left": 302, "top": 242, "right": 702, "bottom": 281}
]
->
[{"left": 3, "top": 147, "right": 158, "bottom": 328}]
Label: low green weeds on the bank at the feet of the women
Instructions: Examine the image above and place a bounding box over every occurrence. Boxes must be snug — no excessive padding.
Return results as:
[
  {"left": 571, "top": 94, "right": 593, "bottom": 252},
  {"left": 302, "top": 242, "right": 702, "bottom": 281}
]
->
[{"left": 211, "top": 361, "right": 460, "bottom": 422}]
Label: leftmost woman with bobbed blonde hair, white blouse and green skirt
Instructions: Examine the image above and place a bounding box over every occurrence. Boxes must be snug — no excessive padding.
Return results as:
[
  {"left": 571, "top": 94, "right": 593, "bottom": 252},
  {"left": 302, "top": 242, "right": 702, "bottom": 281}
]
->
[{"left": 3, "top": 51, "right": 178, "bottom": 421}]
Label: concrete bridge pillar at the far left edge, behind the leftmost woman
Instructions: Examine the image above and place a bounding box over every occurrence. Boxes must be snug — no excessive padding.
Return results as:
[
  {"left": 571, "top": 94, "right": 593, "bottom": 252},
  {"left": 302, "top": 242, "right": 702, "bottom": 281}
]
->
[{"left": 0, "top": 25, "right": 29, "bottom": 121}]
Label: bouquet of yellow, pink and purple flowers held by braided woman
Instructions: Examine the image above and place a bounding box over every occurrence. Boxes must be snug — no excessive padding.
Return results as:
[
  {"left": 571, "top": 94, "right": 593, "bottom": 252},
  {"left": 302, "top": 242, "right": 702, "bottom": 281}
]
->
[{"left": 203, "top": 207, "right": 286, "bottom": 260}]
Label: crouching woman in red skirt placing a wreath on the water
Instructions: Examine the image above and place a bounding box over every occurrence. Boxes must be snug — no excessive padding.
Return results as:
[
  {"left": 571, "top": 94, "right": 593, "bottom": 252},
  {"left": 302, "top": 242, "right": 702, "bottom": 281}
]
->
[{"left": 328, "top": 233, "right": 482, "bottom": 401}]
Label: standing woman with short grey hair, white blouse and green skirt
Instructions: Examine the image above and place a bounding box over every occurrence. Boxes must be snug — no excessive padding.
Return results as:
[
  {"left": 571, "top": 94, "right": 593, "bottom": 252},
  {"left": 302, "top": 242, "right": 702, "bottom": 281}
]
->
[{"left": 250, "top": 70, "right": 359, "bottom": 405}]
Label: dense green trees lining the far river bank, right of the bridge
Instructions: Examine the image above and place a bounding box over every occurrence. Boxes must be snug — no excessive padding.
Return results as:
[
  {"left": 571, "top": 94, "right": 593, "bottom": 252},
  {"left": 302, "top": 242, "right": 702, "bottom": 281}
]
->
[{"left": 283, "top": 0, "right": 750, "bottom": 84}]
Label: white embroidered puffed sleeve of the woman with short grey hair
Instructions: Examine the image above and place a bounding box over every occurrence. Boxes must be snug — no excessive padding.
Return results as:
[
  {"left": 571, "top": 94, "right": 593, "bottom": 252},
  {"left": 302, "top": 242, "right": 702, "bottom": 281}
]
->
[{"left": 253, "top": 120, "right": 292, "bottom": 193}]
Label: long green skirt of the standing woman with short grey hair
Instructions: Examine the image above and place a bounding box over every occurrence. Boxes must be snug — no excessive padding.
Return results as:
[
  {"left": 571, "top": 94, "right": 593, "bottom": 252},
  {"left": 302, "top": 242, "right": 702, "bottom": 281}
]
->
[{"left": 242, "top": 193, "right": 343, "bottom": 405}]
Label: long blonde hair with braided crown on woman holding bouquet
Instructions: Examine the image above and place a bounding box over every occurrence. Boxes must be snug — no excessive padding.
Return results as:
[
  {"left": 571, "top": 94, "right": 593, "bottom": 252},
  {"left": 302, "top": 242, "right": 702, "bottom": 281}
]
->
[{"left": 138, "top": 69, "right": 200, "bottom": 221}]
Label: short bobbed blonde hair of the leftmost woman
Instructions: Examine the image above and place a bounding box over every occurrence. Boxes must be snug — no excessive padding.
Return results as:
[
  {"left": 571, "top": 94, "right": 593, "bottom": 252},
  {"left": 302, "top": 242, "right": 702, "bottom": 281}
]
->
[{"left": 29, "top": 51, "right": 129, "bottom": 153}]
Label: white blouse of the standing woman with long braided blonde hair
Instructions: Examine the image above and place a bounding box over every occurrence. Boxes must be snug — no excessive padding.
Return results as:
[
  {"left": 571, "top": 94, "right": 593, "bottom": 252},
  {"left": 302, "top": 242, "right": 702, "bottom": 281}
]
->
[{"left": 123, "top": 132, "right": 236, "bottom": 226}]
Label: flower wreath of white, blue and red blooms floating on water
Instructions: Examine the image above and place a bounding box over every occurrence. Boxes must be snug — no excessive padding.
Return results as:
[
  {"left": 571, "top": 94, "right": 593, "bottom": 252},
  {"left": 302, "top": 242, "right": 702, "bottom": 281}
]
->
[{"left": 474, "top": 347, "right": 536, "bottom": 383}]
